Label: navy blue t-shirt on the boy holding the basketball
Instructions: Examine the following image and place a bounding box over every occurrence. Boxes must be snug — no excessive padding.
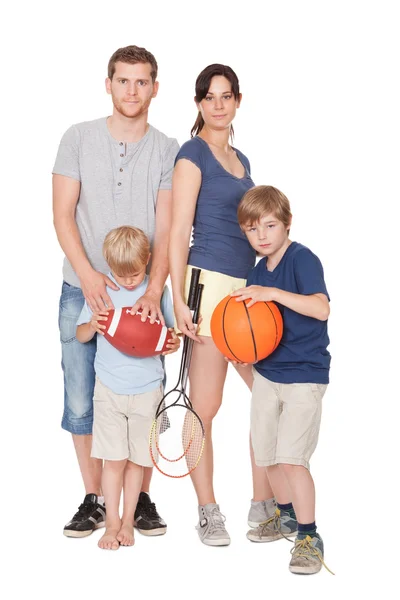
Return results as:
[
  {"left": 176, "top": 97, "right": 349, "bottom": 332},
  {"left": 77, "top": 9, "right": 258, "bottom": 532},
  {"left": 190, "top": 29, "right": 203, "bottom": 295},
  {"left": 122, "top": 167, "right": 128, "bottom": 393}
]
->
[{"left": 247, "top": 242, "right": 331, "bottom": 383}]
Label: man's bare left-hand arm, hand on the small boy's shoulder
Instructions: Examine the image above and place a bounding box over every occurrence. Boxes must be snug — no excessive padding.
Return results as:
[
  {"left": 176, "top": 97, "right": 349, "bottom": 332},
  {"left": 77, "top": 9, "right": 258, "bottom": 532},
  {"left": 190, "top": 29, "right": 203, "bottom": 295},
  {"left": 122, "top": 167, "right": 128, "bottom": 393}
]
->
[{"left": 53, "top": 175, "right": 118, "bottom": 311}]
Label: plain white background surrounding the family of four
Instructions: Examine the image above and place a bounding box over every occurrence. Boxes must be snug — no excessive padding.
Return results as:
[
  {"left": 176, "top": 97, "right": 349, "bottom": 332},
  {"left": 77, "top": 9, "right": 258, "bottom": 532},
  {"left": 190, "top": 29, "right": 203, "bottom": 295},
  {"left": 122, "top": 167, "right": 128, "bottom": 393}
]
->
[{"left": 0, "top": 0, "right": 400, "bottom": 600}]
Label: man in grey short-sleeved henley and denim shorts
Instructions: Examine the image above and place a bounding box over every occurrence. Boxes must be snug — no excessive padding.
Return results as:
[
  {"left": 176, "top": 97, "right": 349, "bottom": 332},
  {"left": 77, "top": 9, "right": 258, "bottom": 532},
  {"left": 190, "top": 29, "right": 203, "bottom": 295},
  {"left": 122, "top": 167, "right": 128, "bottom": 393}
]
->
[{"left": 53, "top": 46, "right": 179, "bottom": 537}]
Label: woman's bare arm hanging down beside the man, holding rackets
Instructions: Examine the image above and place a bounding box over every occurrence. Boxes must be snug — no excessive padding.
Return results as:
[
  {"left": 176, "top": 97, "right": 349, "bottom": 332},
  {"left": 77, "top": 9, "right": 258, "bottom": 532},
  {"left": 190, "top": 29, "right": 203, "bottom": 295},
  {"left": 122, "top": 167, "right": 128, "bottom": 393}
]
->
[{"left": 169, "top": 158, "right": 201, "bottom": 339}]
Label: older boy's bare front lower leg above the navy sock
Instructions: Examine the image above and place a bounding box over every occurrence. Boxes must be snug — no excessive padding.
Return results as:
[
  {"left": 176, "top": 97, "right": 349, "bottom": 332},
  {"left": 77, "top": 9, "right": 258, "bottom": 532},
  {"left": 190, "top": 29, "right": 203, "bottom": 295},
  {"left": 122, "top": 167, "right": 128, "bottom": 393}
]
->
[{"left": 278, "top": 464, "right": 315, "bottom": 523}]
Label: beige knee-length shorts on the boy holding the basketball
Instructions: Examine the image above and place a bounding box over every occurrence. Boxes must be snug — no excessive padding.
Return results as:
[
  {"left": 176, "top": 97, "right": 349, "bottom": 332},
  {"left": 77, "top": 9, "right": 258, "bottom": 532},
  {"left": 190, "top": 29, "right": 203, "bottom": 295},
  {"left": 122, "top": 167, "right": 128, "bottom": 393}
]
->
[{"left": 251, "top": 369, "right": 328, "bottom": 469}]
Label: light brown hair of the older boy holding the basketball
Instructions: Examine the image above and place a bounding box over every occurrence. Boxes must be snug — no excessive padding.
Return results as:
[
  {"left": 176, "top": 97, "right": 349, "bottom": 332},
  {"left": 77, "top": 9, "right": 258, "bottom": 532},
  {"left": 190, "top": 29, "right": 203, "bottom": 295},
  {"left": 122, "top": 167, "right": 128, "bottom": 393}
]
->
[{"left": 238, "top": 185, "right": 292, "bottom": 229}]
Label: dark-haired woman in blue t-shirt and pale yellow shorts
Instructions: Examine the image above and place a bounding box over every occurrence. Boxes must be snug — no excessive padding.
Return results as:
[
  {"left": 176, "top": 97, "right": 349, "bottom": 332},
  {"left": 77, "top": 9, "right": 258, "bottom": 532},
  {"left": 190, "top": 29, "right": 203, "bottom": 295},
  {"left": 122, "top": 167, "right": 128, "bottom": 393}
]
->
[{"left": 169, "top": 64, "right": 275, "bottom": 546}]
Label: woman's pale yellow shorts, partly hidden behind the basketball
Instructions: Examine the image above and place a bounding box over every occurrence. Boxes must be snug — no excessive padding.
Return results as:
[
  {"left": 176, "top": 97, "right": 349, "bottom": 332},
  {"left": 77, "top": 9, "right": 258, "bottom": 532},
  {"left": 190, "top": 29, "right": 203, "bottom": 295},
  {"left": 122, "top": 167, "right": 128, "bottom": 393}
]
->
[{"left": 179, "top": 265, "right": 246, "bottom": 337}]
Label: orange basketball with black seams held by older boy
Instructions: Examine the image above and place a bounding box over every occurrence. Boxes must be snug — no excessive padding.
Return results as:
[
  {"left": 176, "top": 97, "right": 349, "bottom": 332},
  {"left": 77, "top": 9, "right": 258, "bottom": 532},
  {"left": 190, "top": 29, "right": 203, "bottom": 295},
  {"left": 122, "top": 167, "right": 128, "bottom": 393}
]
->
[{"left": 210, "top": 296, "right": 283, "bottom": 363}]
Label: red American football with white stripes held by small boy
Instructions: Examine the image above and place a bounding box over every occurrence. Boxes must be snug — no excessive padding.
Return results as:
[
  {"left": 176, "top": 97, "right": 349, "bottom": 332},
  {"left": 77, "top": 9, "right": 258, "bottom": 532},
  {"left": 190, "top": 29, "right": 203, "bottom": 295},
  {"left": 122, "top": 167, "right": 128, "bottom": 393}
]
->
[{"left": 101, "top": 306, "right": 170, "bottom": 358}]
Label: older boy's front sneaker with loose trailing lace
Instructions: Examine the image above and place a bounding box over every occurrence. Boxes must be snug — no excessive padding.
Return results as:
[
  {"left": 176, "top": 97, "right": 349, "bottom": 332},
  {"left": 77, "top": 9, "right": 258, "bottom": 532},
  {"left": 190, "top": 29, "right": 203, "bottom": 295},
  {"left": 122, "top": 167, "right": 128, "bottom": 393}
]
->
[{"left": 289, "top": 533, "right": 334, "bottom": 575}]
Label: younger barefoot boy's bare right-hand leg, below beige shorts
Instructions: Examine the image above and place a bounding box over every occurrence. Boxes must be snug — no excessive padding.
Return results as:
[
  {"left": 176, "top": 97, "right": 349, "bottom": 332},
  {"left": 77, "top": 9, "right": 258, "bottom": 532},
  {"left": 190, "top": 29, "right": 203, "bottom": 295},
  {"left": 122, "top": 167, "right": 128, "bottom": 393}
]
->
[{"left": 117, "top": 460, "right": 147, "bottom": 546}]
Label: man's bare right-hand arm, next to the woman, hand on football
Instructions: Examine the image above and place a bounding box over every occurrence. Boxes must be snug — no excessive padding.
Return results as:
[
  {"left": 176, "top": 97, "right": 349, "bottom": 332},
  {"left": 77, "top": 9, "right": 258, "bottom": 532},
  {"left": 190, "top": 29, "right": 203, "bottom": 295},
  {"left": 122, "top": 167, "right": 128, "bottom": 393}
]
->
[{"left": 132, "top": 190, "right": 172, "bottom": 325}]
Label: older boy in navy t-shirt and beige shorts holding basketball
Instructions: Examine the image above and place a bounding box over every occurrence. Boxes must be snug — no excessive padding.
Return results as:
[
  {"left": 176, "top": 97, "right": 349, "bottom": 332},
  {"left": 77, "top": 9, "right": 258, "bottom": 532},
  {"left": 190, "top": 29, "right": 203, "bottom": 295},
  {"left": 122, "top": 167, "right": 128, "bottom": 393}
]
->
[{"left": 233, "top": 186, "right": 330, "bottom": 573}]
